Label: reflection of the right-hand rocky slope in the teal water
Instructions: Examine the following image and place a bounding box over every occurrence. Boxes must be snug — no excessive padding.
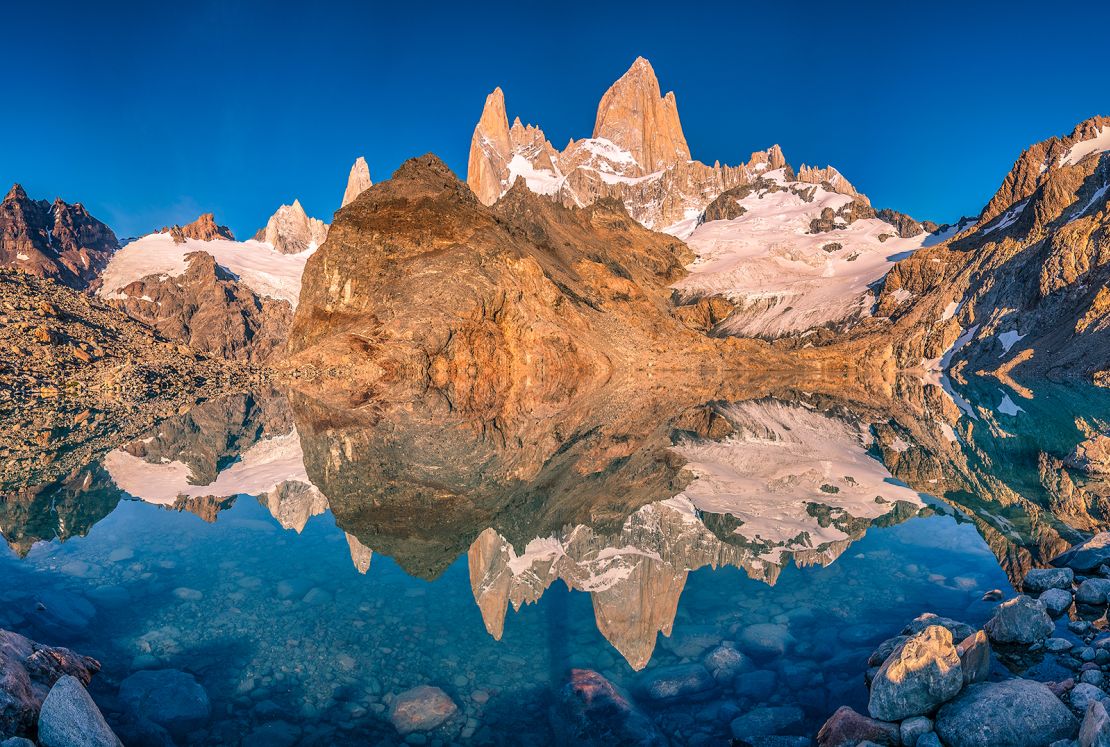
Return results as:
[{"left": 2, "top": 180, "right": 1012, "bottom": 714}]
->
[{"left": 875, "top": 377, "right": 1110, "bottom": 582}]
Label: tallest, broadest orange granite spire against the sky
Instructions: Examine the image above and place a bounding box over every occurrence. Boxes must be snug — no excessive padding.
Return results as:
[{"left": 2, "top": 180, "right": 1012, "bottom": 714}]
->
[{"left": 594, "top": 57, "right": 690, "bottom": 173}]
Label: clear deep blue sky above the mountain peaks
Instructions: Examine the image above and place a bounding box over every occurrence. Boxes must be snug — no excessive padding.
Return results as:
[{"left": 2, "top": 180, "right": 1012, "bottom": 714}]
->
[{"left": 0, "top": 0, "right": 1110, "bottom": 235}]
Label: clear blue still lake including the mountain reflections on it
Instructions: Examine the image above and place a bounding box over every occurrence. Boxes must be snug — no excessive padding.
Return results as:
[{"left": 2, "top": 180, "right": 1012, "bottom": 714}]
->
[{"left": 0, "top": 387, "right": 1104, "bottom": 745}]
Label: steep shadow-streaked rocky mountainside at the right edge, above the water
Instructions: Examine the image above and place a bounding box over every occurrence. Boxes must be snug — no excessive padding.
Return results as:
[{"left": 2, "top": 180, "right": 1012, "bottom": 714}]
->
[{"left": 879, "top": 117, "right": 1110, "bottom": 381}]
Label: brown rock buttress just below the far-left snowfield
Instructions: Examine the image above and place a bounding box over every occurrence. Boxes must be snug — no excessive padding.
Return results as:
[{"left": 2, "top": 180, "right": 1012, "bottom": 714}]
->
[{"left": 109, "top": 251, "right": 293, "bottom": 363}]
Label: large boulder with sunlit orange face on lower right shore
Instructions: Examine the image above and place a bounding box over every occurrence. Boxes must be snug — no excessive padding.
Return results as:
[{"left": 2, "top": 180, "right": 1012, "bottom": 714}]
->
[{"left": 867, "top": 625, "right": 963, "bottom": 721}]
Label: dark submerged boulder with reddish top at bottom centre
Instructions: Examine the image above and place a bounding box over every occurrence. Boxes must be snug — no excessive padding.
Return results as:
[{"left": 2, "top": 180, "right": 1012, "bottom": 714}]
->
[{"left": 551, "top": 669, "right": 667, "bottom": 747}]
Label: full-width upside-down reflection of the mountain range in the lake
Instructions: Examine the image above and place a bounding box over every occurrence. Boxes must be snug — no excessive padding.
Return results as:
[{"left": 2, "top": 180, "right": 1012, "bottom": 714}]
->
[{"left": 0, "top": 378, "right": 1110, "bottom": 668}]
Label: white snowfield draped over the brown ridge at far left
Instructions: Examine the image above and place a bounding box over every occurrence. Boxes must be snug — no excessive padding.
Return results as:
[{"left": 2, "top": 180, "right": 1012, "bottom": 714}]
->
[{"left": 99, "top": 233, "right": 315, "bottom": 307}]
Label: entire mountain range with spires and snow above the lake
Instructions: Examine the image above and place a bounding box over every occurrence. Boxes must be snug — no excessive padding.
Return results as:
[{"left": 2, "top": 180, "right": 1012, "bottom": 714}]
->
[{"left": 0, "top": 58, "right": 1110, "bottom": 404}]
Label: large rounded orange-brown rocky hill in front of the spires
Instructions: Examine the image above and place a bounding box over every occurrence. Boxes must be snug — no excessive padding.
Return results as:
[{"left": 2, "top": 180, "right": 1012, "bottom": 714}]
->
[{"left": 290, "top": 157, "right": 765, "bottom": 412}]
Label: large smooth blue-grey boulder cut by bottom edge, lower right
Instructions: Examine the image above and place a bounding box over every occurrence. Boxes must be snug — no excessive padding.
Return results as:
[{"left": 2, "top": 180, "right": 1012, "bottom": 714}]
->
[{"left": 932, "top": 679, "right": 1079, "bottom": 747}]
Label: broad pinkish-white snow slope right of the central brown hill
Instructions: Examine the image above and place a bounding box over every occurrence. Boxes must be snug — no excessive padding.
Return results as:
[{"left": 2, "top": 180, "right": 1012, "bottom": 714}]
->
[{"left": 668, "top": 169, "right": 930, "bottom": 337}]
